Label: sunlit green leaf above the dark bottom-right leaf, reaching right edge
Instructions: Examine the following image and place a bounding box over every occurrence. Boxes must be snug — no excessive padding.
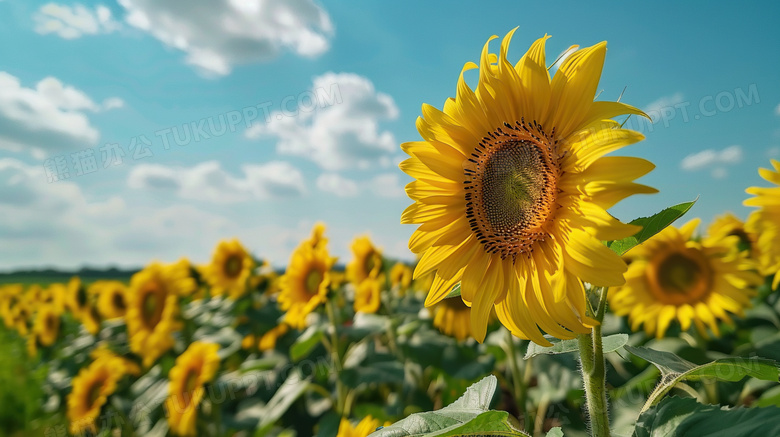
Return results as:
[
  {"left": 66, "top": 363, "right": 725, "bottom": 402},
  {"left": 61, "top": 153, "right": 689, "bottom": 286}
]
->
[{"left": 625, "top": 346, "right": 780, "bottom": 411}]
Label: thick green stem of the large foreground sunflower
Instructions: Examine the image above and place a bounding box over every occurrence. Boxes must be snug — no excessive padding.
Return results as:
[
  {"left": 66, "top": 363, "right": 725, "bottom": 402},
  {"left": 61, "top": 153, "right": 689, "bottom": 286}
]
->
[{"left": 577, "top": 287, "right": 610, "bottom": 437}]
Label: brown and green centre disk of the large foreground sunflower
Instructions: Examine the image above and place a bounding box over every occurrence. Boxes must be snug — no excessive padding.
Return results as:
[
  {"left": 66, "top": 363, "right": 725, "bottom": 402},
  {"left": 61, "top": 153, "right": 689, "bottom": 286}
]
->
[{"left": 465, "top": 128, "right": 559, "bottom": 259}]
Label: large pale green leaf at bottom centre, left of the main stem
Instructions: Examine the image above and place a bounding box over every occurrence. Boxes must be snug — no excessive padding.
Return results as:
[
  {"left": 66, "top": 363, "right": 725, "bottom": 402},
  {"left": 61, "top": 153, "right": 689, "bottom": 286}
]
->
[{"left": 371, "top": 375, "right": 526, "bottom": 437}]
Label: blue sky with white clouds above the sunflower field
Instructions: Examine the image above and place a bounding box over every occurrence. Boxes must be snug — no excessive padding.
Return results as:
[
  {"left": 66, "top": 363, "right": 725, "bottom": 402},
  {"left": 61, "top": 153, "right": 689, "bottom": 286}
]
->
[{"left": 0, "top": 0, "right": 780, "bottom": 270}]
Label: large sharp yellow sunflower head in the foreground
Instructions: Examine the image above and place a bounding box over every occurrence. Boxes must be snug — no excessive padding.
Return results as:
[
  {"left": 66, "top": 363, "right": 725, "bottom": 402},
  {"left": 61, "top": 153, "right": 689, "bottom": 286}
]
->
[{"left": 400, "top": 30, "right": 656, "bottom": 345}]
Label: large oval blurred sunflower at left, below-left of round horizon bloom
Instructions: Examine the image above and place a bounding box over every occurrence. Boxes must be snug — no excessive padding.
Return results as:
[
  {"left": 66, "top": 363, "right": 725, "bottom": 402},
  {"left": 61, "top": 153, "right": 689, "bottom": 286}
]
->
[{"left": 125, "top": 263, "right": 186, "bottom": 367}]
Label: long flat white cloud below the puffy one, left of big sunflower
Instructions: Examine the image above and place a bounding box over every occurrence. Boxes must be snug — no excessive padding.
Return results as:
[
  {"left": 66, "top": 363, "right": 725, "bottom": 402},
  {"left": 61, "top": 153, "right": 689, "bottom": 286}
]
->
[{"left": 127, "top": 161, "right": 306, "bottom": 203}]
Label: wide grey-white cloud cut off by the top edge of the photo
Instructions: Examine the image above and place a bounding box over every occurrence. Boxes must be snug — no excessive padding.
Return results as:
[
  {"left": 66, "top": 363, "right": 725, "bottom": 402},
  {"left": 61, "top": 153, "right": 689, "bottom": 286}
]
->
[{"left": 119, "top": 0, "right": 333, "bottom": 75}]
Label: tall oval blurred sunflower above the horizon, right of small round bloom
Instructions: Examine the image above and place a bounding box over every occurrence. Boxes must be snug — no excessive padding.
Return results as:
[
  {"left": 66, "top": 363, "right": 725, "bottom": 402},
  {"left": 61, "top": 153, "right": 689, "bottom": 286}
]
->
[{"left": 277, "top": 240, "right": 336, "bottom": 329}]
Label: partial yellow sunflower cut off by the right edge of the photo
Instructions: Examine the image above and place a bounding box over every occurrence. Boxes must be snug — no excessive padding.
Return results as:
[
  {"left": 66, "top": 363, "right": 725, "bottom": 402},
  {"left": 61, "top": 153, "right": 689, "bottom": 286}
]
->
[{"left": 744, "top": 159, "right": 780, "bottom": 289}]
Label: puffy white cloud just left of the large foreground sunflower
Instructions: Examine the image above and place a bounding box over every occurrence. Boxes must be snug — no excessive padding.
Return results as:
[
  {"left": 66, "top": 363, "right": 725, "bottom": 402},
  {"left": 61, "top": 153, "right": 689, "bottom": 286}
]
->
[{"left": 246, "top": 73, "right": 398, "bottom": 171}]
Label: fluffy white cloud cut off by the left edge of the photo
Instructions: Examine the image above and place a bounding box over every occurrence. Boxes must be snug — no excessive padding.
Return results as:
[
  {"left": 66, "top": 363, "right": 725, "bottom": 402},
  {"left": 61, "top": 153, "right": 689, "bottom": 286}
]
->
[{"left": 0, "top": 71, "right": 124, "bottom": 158}]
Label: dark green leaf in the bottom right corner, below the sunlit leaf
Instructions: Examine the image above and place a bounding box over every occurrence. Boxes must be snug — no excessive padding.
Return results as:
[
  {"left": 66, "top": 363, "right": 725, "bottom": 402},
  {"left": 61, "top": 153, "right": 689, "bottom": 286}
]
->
[{"left": 634, "top": 396, "right": 780, "bottom": 437}]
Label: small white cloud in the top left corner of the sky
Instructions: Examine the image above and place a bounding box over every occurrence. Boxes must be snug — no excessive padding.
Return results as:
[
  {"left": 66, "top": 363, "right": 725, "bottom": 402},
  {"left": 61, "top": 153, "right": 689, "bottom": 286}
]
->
[{"left": 33, "top": 3, "right": 119, "bottom": 39}]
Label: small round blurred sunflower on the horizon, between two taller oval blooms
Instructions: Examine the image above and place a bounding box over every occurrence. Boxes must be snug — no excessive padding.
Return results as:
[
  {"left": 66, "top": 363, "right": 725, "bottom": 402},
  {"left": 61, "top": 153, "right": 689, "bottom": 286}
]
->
[{"left": 206, "top": 240, "right": 255, "bottom": 299}]
